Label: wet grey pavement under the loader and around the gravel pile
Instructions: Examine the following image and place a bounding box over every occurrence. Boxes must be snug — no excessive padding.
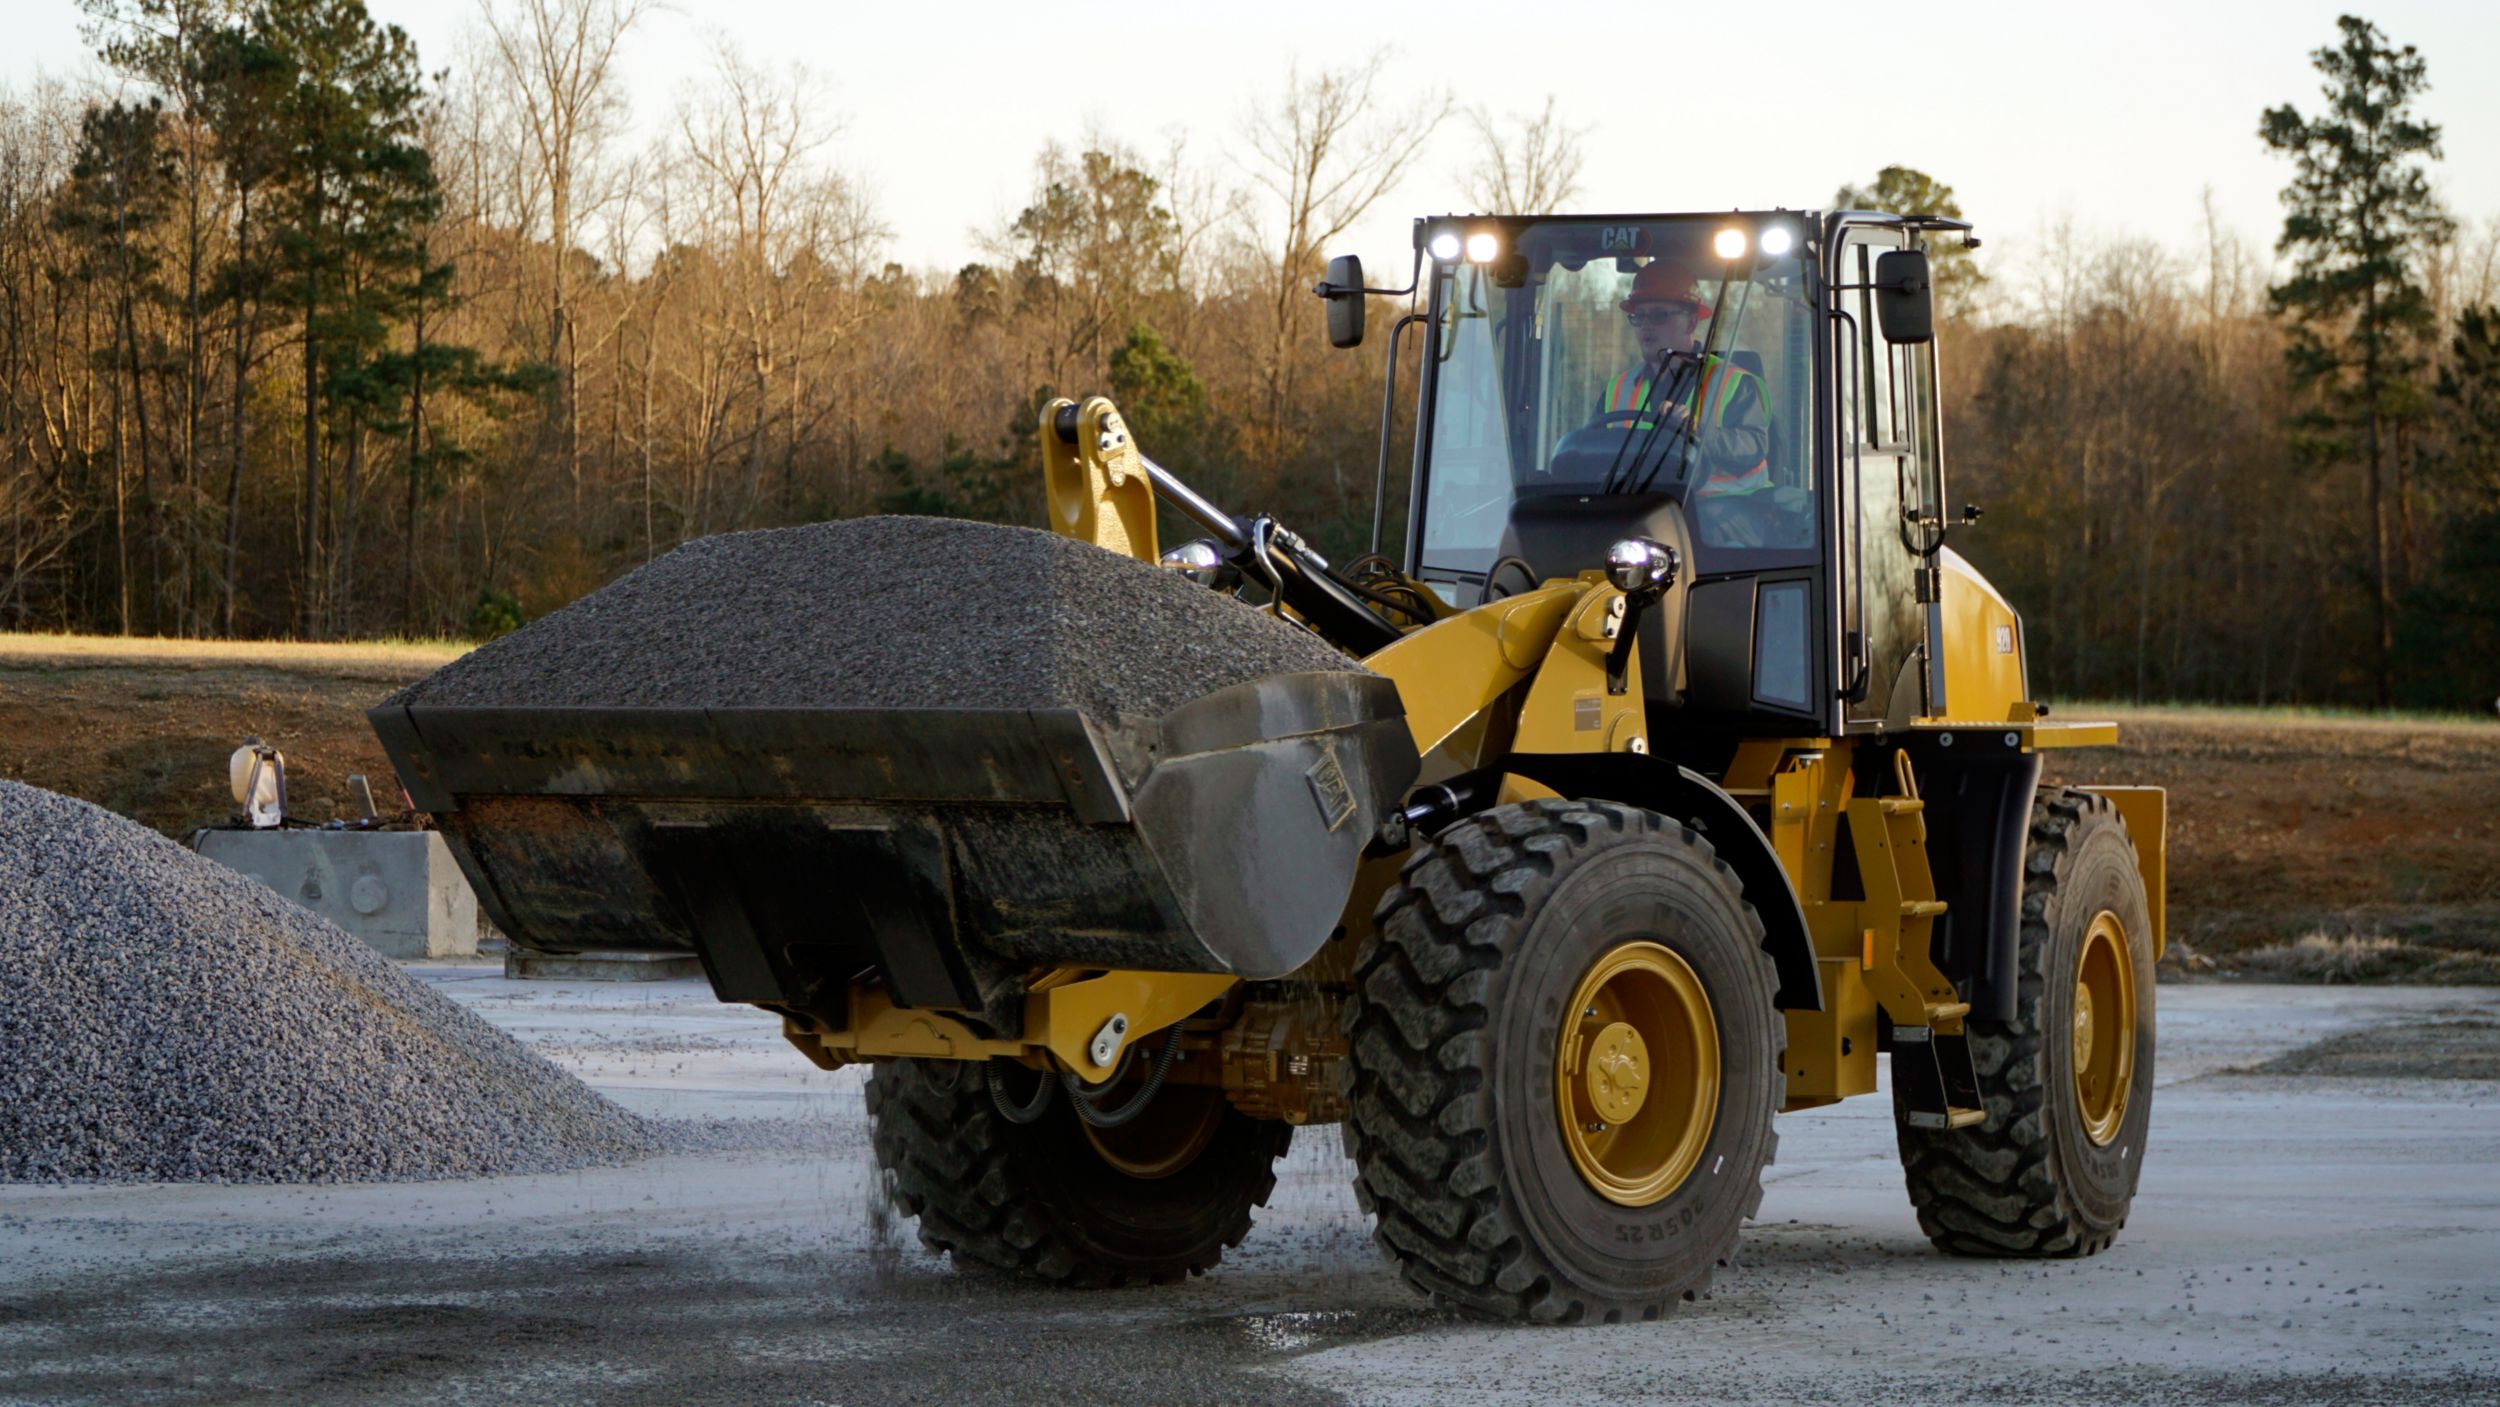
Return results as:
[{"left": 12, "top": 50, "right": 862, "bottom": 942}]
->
[{"left": 0, "top": 965, "right": 2500, "bottom": 1407}]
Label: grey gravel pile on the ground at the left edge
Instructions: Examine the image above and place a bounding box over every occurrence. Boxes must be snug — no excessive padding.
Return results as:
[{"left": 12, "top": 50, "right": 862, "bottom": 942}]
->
[{"left": 0, "top": 782, "right": 670, "bottom": 1182}]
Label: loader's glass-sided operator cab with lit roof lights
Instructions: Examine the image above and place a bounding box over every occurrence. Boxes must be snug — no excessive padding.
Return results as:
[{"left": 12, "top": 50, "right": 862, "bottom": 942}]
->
[{"left": 1390, "top": 212, "right": 1943, "bottom": 735}]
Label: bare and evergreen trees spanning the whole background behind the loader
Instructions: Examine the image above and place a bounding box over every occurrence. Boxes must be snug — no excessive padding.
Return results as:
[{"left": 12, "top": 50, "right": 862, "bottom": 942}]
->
[{"left": 0, "top": 0, "right": 2500, "bottom": 707}]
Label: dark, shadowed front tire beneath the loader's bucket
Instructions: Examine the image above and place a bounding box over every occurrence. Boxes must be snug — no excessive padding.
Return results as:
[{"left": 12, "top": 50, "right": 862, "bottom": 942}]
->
[{"left": 868, "top": 1060, "right": 1293, "bottom": 1287}]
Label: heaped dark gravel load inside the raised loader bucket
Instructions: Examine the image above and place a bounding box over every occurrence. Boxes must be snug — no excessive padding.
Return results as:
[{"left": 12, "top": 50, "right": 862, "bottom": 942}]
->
[{"left": 390, "top": 517, "right": 1360, "bottom": 717}]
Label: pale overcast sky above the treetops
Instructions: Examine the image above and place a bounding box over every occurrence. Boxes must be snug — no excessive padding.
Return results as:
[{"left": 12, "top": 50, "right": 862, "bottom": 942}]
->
[{"left": 0, "top": 0, "right": 2500, "bottom": 294}]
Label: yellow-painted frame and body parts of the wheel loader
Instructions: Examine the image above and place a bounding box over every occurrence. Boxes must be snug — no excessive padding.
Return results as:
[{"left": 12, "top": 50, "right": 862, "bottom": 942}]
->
[{"left": 805, "top": 397, "right": 2165, "bottom": 1110}]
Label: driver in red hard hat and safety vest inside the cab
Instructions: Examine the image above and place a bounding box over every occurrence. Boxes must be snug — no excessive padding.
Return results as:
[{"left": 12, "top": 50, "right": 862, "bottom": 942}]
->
[{"left": 1598, "top": 257, "right": 1793, "bottom": 547}]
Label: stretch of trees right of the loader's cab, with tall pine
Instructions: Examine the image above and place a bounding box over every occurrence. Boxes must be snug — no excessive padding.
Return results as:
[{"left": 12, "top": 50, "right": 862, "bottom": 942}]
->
[{"left": 1950, "top": 15, "right": 2500, "bottom": 712}]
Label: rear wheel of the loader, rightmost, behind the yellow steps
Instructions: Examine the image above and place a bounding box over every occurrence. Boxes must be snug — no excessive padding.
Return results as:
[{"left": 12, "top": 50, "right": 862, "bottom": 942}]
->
[{"left": 1893, "top": 790, "right": 2153, "bottom": 1257}]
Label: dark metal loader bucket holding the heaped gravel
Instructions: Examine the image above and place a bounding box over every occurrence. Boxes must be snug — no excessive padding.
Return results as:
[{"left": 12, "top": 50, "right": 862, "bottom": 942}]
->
[{"left": 368, "top": 670, "right": 1418, "bottom": 1030}]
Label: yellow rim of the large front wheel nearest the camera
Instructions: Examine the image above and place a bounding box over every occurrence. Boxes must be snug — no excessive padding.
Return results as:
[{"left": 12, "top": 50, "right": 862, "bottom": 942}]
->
[{"left": 1555, "top": 942, "right": 1720, "bottom": 1207}]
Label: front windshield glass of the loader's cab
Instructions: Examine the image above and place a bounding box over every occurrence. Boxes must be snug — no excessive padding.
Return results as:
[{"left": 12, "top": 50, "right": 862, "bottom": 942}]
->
[{"left": 1418, "top": 215, "right": 1820, "bottom": 597}]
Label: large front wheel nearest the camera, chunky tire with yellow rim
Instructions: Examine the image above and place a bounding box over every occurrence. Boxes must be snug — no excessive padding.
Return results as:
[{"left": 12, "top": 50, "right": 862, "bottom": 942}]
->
[{"left": 1343, "top": 800, "right": 1788, "bottom": 1322}]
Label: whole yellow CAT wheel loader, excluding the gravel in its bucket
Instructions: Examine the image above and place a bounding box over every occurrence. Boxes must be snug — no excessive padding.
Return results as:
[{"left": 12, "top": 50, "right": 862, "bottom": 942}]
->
[{"left": 373, "top": 210, "right": 2163, "bottom": 1322}]
